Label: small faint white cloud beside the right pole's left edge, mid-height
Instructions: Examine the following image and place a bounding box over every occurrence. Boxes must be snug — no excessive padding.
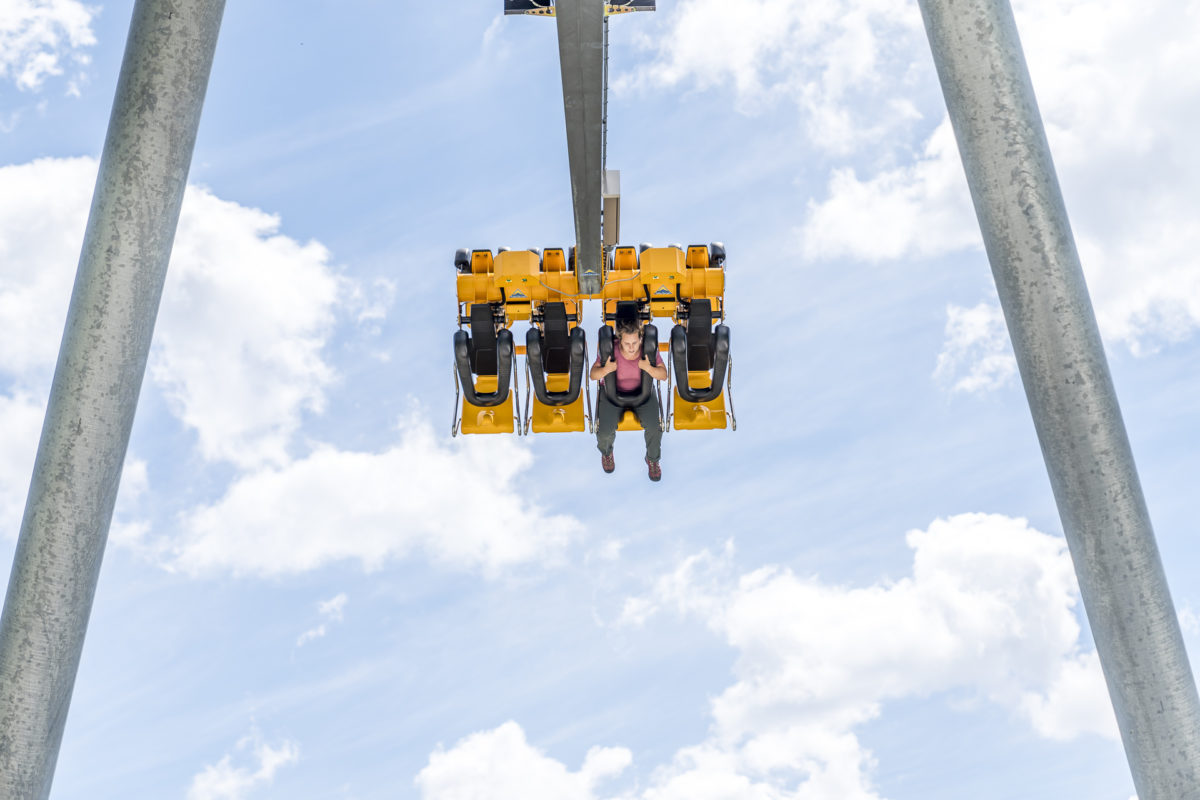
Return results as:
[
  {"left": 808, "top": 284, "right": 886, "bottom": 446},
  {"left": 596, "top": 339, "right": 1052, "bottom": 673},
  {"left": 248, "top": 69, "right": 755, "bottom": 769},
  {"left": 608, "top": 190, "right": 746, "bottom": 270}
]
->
[{"left": 934, "top": 302, "right": 1016, "bottom": 392}]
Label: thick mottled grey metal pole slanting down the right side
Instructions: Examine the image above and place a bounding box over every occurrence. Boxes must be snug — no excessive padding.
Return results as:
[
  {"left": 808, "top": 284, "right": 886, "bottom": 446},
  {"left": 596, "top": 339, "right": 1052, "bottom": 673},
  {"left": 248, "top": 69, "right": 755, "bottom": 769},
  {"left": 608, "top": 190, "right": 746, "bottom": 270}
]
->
[{"left": 919, "top": 0, "right": 1200, "bottom": 800}]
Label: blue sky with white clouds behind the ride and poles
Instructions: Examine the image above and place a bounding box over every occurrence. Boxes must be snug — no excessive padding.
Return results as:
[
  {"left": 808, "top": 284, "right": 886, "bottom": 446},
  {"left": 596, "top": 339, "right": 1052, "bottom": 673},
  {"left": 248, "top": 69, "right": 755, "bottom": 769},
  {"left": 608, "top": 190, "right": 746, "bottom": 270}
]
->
[{"left": 0, "top": 0, "right": 1200, "bottom": 800}]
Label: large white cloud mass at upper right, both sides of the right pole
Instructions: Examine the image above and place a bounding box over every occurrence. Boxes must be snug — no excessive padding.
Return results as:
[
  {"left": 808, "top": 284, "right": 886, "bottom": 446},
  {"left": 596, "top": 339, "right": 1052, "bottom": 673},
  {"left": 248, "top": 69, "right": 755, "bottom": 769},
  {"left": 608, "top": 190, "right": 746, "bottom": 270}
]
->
[{"left": 638, "top": 0, "right": 1200, "bottom": 376}]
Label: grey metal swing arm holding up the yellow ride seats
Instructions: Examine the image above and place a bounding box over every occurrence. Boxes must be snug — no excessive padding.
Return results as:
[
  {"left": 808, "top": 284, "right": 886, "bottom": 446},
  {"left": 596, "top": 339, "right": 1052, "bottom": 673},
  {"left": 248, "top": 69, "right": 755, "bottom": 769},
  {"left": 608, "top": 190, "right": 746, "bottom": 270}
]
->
[{"left": 554, "top": 0, "right": 605, "bottom": 294}]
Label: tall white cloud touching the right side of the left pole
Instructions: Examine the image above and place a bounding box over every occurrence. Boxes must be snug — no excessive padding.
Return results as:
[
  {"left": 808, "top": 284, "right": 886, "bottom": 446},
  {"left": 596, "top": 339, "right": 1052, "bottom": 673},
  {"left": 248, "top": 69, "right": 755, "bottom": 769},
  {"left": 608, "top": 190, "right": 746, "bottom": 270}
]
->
[{"left": 150, "top": 186, "right": 343, "bottom": 467}]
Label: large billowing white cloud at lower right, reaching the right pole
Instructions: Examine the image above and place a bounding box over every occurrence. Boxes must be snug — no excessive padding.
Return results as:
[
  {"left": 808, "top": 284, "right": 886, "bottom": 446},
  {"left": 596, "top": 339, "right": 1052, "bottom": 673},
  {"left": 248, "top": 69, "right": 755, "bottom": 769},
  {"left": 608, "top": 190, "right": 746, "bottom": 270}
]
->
[{"left": 431, "top": 513, "right": 1117, "bottom": 800}]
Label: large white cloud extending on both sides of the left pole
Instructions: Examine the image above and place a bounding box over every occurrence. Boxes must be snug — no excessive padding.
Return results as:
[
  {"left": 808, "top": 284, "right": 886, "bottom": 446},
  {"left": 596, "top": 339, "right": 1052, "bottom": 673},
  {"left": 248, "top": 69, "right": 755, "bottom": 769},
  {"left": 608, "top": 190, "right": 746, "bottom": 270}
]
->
[{"left": 0, "top": 158, "right": 350, "bottom": 467}]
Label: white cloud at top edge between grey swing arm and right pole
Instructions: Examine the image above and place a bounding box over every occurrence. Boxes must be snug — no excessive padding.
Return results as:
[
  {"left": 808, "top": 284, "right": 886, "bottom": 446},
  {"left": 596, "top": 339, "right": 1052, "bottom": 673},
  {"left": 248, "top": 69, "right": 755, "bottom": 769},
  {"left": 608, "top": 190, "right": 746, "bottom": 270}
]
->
[{"left": 613, "top": 0, "right": 924, "bottom": 154}]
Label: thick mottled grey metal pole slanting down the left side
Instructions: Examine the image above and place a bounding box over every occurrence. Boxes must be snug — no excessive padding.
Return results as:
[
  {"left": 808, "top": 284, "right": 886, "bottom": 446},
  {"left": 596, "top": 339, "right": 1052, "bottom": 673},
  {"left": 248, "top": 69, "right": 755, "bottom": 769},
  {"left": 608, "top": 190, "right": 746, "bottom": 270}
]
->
[{"left": 0, "top": 0, "right": 224, "bottom": 800}]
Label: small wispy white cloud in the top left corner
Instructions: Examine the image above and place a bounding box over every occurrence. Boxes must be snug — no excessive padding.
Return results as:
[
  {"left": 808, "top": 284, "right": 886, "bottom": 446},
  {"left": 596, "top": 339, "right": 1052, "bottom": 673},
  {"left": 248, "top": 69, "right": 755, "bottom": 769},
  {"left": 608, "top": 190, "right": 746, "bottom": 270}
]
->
[{"left": 0, "top": 0, "right": 98, "bottom": 91}]
